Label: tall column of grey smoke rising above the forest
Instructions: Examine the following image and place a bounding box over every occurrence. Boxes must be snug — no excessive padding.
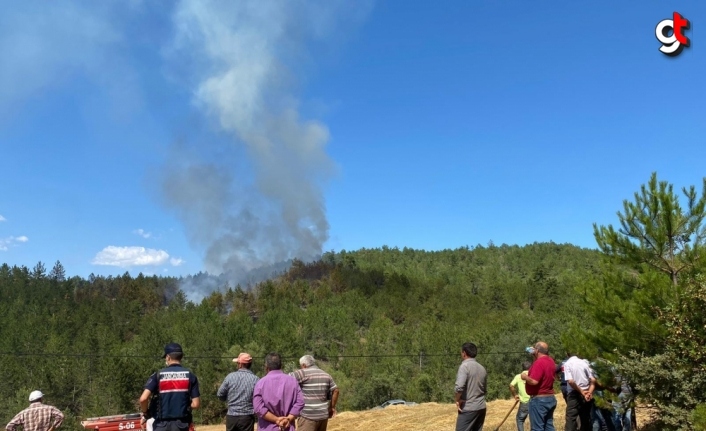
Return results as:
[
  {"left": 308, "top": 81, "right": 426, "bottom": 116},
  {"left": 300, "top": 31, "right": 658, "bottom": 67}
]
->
[{"left": 163, "top": 0, "right": 369, "bottom": 280}]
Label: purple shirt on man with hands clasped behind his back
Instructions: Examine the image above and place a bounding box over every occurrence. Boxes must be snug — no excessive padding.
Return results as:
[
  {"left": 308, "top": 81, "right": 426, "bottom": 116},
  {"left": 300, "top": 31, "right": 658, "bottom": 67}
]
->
[{"left": 252, "top": 370, "right": 304, "bottom": 431}]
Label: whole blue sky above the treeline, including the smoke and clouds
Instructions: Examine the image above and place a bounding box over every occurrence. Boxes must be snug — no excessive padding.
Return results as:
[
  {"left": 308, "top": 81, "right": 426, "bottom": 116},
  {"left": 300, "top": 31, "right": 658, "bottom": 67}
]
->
[{"left": 0, "top": 0, "right": 706, "bottom": 277}]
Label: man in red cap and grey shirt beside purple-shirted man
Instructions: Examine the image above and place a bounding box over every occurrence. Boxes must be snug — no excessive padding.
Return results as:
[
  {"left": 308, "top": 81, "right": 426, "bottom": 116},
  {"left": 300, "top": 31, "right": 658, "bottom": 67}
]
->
[{"left": 217, "top": 353, "right": 260, "bottom": 431}]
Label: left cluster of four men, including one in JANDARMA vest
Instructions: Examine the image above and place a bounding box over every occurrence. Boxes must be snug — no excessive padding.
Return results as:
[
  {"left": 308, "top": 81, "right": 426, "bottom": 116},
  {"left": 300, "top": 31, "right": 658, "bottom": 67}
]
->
[{"left": 140, "top": 343, "right": 339, "bottom": 431}]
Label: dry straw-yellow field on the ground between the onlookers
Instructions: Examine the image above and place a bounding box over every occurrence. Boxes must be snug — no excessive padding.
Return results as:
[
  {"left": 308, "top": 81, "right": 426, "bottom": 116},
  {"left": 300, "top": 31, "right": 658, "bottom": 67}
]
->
[{"left": 196, "top": 396, "right": 650, "bottom": 431}]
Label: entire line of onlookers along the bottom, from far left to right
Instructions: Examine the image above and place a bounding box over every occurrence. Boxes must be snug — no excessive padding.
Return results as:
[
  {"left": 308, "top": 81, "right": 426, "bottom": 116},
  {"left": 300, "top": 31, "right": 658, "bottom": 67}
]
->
[{"left": 6, "top": 341, "right": 631, "bottom": 431}]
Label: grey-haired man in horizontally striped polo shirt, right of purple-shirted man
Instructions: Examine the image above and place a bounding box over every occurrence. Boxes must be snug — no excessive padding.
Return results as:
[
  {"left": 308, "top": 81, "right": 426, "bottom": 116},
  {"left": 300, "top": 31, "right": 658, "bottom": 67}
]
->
[{"left": 292, "top": 355, "right": 338, "bottom": 431}]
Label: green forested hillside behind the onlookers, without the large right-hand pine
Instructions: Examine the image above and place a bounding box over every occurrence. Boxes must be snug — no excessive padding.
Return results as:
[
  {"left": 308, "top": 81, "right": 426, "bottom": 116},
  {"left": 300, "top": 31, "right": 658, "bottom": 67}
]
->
[{"left": 0, "top": 243, "right": 600, "bottom": 423}]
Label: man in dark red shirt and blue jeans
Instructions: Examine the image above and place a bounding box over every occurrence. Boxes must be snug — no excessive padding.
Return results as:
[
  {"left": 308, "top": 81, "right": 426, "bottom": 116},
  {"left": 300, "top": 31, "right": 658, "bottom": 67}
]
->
[{"left": 522, "top": 341, "right": 556, "bottom": 431}]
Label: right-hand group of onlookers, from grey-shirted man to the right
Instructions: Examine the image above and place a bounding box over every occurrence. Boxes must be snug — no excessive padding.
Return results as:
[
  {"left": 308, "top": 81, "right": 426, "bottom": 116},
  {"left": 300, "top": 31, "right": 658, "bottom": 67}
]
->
[{"left": 455, "top": 341, "right": 631, "bottom": 431}]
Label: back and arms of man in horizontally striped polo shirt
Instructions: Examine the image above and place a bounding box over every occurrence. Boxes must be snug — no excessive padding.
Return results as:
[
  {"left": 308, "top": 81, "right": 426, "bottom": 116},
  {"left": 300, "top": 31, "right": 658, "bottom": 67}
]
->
[{"left": 291, "top": 365, "right": 337, "bottom": 421}]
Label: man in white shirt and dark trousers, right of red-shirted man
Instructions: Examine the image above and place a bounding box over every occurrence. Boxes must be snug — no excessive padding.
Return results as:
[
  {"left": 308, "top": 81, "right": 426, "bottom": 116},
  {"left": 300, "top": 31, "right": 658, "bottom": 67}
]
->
[{"left": 564, "top": 355, "right": 596, "bottom": 431}]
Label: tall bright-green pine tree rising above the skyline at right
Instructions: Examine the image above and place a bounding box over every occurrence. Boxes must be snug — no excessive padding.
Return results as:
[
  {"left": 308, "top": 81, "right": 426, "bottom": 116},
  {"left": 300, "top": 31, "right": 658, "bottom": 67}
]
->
[{"left": 565, "top": 173, "right": 706, "bottom": 356}]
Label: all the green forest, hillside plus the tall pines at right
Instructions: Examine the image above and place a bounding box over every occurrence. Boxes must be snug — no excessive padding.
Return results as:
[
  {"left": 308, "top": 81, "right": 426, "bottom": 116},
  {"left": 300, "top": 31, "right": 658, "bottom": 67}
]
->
[{"left": 0, "top": 174, "right": 706, "bottom": 430}]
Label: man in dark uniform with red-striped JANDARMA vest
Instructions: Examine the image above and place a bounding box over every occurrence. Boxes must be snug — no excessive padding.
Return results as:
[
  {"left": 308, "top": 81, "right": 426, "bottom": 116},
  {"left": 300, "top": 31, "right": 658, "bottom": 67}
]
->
[{"left": 140, "top": 343, "right": 201, "bottom": 431}]
